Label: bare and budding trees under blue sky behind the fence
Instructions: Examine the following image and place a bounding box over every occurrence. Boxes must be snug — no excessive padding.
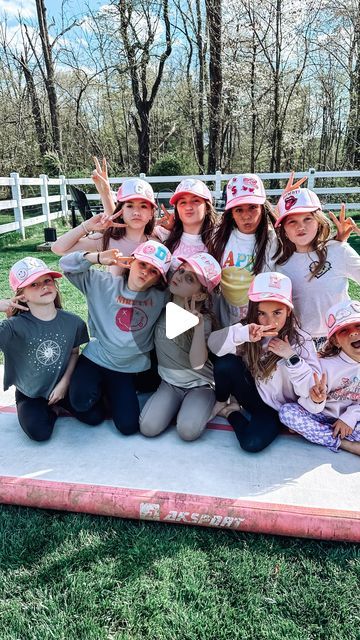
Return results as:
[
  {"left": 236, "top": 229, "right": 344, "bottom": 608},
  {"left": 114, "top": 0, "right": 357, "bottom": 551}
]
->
[{"left": 0, "top": 0, "right": 360, "bottom": 177}]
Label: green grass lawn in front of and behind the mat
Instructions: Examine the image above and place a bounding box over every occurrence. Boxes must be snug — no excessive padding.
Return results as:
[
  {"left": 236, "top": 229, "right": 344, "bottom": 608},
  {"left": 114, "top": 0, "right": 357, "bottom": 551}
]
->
[{"left": 0, "top": 225, "right": 360, "bottom": 640}]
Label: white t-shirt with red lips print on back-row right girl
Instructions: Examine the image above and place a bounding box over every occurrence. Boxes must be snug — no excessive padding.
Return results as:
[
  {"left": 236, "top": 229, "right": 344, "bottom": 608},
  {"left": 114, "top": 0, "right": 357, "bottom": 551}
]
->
[{"left": 276, "top": 240, "right": 360, "bottom": 338}]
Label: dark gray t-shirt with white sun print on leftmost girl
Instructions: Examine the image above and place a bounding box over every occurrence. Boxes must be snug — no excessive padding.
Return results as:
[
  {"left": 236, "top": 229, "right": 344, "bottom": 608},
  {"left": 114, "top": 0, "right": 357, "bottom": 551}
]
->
[{"left": 0, "top": 309, "right": 89, "bottom": 398}]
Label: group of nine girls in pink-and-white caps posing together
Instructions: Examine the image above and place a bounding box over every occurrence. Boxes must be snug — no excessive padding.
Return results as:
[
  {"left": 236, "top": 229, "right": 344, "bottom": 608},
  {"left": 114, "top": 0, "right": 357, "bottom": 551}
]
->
[{"left": 0, "top": 161, "right": 360, "bottom": 454}]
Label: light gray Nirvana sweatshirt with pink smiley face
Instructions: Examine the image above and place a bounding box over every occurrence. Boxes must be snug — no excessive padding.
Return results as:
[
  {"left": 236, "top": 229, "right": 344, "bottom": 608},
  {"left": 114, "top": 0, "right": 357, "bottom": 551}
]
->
[{"left": 60, "top": 251, "right": 166, "bottom": 373}]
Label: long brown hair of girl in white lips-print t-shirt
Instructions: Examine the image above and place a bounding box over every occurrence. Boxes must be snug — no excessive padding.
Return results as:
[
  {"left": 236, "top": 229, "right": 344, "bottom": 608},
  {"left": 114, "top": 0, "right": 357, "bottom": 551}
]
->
[{"left": 273, "top": 209, "right": 331, "bottom": 280}]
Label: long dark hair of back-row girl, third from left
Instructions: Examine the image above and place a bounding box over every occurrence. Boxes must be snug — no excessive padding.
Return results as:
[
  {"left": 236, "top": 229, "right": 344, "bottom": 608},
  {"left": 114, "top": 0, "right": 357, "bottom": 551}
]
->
[{"left": 209, "top": 200, "right": 272, "bottom": 276}]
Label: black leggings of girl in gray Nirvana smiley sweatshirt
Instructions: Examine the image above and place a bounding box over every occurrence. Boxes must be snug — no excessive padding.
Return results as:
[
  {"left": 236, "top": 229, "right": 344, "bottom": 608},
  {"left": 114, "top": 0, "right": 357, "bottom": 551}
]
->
[{"left": 69, "top": 355, "right": 140, "bottom": 436}]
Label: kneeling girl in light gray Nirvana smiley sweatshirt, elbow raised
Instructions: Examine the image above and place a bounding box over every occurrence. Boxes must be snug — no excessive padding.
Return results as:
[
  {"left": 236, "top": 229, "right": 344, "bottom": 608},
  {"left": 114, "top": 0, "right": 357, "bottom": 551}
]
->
[{"left": 60, "top": 240, "right": 171, "bottom": 435}]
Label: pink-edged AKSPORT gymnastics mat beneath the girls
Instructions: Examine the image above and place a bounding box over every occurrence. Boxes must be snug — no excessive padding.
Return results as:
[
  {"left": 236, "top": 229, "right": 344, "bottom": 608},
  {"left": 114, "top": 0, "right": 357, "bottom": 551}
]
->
[{"left": 0, "top": 368, "right": 360, "bottom": 542}]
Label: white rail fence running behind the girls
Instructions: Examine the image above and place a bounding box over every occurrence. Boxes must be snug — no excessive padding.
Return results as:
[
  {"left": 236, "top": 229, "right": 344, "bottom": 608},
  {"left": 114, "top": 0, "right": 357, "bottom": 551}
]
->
[{"left": 0, "top": 168, "right": 360, "bottom": 238}]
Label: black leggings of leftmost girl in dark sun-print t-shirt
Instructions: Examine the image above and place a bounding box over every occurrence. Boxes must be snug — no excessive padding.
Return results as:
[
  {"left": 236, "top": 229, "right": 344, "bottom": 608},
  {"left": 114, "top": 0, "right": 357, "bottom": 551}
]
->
[{"left": 15, "top": 389, "right": 104, "bottom": 442}]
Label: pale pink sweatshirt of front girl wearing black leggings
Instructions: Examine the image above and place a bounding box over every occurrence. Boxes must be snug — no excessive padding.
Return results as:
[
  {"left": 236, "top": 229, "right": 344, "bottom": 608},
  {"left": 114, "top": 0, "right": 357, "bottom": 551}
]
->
[{"left": 208, "top": 323, "right": 320, "bottom": 411}]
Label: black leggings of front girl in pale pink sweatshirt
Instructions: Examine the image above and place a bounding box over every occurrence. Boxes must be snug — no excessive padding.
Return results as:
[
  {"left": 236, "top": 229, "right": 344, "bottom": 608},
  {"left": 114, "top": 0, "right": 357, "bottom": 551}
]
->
[{"left": 214, "top": 354, "right": 281, "bottom": 453}]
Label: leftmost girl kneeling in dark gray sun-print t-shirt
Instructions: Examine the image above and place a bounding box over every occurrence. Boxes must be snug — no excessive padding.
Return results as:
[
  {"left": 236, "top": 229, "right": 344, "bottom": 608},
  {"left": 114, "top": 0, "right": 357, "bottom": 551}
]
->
[{"left": 0, "top": 257, "right": 95, "bottom": 442}]
